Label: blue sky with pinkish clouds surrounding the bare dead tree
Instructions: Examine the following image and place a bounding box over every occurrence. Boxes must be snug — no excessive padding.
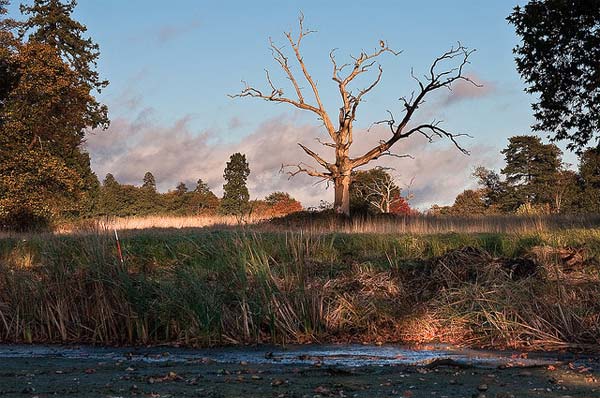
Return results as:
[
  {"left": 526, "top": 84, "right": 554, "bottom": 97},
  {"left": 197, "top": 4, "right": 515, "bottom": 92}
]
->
[{"left": 13, "top": 0, "right": 572, "bottom": 207}]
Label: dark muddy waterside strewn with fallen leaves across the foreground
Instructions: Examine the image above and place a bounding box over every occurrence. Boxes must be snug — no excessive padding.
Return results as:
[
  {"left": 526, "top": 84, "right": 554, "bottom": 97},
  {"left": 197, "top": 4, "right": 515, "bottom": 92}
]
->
[{"left": 0, "top": 346, "right": 600, "bottom": 398}]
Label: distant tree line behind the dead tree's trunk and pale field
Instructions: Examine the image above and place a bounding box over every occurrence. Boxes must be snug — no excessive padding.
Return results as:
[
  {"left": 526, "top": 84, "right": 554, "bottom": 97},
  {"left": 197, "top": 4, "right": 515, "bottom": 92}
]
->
[{"left": 95, "top": 153, "right": 414, "bottom": 218}]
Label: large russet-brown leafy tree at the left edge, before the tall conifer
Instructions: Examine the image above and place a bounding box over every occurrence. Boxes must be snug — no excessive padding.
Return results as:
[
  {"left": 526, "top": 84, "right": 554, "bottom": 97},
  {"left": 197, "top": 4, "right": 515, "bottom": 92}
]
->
[{"left": 0, "top": 42, "right": 97, "bottom": 224}]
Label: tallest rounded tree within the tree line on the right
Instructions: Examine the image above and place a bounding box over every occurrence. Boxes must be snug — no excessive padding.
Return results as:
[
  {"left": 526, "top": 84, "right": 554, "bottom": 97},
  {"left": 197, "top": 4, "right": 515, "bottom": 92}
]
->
[{"left": 502, "top": 135, "right": 562, "bottom": 210}]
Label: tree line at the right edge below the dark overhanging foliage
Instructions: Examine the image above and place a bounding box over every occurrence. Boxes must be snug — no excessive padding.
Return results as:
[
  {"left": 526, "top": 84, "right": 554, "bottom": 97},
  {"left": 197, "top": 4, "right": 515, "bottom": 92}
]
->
[{"left": 431, "top": 135, "right": 600, "bottom": 215}]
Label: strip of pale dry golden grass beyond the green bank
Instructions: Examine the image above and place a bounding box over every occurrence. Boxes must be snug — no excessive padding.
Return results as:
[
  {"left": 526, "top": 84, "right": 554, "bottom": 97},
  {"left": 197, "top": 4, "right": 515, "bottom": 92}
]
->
[{"left": 51, "top": 212, "right": 600, "bottom": 234}]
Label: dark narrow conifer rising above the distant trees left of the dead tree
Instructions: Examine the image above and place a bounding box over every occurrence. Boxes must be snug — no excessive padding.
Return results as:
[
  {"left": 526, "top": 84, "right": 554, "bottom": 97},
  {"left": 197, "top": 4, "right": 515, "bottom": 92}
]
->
[{"left": 221, "top": 152, "right": 250, "bottom": 217}]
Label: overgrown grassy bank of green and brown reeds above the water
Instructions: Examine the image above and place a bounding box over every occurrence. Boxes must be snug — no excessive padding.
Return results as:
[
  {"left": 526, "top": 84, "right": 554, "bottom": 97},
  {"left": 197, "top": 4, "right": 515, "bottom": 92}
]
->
[{"left": 0, "top": 229, "right": 600, "bottom": 348}]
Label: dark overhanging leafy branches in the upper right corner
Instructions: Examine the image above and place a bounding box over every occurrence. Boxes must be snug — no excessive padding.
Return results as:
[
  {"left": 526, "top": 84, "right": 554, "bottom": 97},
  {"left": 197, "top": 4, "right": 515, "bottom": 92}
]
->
[{"left": 508, "top": 0, "right": 600, "bottom": 151}]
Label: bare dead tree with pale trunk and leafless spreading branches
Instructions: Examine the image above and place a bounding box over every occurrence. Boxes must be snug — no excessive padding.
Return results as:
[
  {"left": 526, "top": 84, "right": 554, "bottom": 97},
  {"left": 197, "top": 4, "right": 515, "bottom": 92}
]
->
[{"left": 232, "top": 15, "right": 477, "bottom": 215}]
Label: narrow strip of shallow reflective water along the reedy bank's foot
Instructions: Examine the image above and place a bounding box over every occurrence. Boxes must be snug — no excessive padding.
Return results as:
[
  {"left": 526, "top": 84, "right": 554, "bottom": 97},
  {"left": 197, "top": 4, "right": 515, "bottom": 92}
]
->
[{"left": 0, "top": 345, "right": 568, "bottom": 367}]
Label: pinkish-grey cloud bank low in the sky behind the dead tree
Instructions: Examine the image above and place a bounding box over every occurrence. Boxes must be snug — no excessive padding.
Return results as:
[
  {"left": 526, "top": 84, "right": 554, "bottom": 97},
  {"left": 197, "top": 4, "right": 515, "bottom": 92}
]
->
[{"left": 87, "top": 109, "right": 494, "bottom": 208}]
